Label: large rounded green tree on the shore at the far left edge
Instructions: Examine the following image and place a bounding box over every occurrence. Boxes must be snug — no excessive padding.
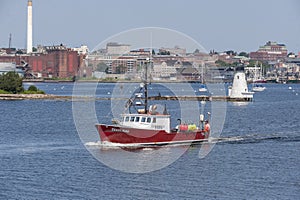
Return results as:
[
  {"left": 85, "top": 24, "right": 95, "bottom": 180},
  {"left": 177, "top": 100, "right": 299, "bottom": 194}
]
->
[{"left": 0, "top": 71, "right": 24, "bottom": 94}]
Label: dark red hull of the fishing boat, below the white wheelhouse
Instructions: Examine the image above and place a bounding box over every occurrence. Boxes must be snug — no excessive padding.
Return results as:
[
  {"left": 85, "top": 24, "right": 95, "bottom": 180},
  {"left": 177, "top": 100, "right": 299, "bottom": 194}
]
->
[{"left": 96, "top": 124, "right": 208, "bottom": 144}]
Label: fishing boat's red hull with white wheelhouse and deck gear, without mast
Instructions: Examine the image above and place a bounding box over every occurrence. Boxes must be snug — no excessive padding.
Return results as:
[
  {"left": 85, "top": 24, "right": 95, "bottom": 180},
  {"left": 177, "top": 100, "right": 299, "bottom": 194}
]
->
[{"left": 96, "top": 114, "right": 208, "bottom": 145}]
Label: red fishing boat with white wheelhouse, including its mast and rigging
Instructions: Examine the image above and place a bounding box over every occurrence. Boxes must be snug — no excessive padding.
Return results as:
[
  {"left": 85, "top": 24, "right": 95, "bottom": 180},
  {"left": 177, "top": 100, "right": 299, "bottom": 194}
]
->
[{"left": 96, "top": 59, "right": 210, "bottom": 146}]
